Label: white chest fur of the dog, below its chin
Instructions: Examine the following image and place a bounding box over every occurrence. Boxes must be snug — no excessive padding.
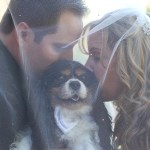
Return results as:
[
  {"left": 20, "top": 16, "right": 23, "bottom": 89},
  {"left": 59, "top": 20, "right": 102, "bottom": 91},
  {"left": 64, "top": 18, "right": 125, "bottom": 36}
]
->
[{"left": 56, "top": 105, "right": 102, "bottom": 150}]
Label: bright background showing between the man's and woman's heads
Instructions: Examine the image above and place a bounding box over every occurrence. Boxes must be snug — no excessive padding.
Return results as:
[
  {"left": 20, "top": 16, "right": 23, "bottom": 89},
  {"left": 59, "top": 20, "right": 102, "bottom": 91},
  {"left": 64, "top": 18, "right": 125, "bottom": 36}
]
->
[{"left": 74, "top": 0, "right": 150, "bottom": 64}]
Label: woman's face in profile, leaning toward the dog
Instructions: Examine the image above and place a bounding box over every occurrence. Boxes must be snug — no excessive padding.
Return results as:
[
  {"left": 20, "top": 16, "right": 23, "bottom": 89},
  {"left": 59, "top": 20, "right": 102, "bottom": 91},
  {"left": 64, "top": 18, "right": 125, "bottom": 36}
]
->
[{"left": 86, "top": 32, "right": 123, "bottom": 101}]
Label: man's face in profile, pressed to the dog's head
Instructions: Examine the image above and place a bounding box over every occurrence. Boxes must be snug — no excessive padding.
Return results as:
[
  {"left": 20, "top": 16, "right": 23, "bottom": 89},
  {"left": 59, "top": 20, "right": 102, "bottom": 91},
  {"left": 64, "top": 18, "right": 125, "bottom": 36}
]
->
[{"left": 19, "top": 11, "right": 83, "bottom": 71}]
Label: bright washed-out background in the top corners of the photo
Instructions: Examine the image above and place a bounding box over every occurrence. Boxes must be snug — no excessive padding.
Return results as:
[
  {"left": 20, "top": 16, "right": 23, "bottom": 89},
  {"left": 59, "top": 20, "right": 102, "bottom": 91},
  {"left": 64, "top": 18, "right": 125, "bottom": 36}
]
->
[{"left": 0, "top": 0, "right": 150, "bottom": 22}]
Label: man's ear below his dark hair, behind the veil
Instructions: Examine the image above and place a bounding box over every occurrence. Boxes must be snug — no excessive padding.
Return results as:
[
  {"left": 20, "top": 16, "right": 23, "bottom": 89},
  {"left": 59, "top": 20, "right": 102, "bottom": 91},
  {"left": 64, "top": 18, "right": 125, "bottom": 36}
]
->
[{"left": 16, "top": 22, "right": 33, "bottom": 42}]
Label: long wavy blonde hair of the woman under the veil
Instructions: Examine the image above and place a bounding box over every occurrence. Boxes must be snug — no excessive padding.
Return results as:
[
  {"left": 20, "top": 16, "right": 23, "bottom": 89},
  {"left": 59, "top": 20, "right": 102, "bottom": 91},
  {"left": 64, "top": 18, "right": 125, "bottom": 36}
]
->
[{"left": 79, "top": 12, "right": 150, "bottom": 150}]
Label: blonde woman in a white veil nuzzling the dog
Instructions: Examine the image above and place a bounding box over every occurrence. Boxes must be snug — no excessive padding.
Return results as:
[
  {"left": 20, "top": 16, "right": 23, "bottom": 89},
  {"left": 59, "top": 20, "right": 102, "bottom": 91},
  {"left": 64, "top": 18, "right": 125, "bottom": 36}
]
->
[{"left": 79, "top": 8, "right": 150, "bottom": 150}]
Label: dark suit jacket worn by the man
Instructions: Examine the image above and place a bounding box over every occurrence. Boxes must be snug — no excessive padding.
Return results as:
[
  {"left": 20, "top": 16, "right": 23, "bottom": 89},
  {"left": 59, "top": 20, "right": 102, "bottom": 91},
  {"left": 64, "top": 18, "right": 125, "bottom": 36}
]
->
[{"left": 0, "top": 41, "right": 26, "bottom": 150}]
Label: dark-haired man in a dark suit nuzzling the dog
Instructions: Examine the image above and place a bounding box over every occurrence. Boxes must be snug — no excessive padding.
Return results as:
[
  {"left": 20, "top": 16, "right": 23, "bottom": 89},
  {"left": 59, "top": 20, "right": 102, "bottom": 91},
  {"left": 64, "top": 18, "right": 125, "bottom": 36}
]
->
[{"left": 0, "top": 0, "right": 86, "bottom": 150}]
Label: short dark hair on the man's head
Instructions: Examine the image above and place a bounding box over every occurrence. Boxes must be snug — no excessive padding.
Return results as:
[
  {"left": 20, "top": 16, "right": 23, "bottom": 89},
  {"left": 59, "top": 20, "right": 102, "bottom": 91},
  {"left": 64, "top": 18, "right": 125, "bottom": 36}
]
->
[{"left": 0, "top": 0, "right": 87, "bottom": 42}]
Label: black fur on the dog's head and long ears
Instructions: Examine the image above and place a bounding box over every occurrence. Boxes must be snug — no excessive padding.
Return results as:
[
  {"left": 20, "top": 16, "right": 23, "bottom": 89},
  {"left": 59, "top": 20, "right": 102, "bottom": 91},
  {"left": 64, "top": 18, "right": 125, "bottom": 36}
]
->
[{"left": 24, "top": 60, "right": 112, "bottom": 150}]
